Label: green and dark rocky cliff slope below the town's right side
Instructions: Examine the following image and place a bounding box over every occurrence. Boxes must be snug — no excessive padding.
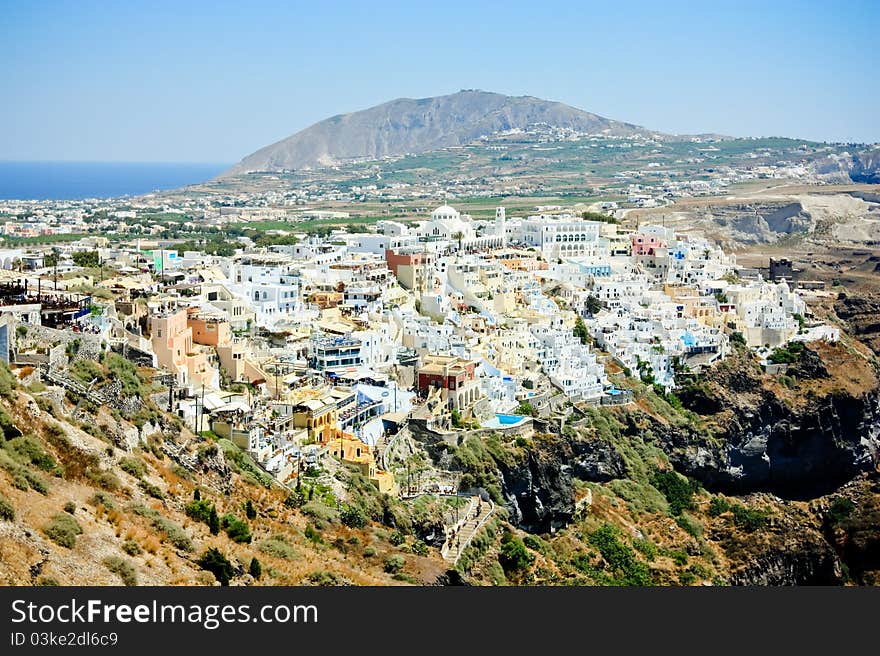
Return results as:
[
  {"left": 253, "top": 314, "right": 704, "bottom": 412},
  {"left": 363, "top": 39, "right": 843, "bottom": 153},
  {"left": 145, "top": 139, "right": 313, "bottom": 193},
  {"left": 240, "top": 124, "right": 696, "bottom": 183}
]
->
[{"left": 422, "top": 344, "right": 880, "bottom": 585}]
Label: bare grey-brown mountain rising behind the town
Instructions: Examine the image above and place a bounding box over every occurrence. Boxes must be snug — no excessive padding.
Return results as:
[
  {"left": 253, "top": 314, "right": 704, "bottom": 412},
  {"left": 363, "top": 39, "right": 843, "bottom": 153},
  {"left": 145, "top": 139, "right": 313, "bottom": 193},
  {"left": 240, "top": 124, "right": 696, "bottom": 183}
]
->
[{"left": 224, "top": 90, "right": 659, "bottom": 175}]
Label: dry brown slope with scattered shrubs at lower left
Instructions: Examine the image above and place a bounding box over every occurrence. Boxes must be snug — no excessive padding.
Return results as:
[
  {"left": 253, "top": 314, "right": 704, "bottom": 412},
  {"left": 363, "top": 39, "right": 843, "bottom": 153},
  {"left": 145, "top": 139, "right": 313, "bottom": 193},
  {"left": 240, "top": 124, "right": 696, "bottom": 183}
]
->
[{"left": 0, "top": 364, "right": 447, "bottom": 585}]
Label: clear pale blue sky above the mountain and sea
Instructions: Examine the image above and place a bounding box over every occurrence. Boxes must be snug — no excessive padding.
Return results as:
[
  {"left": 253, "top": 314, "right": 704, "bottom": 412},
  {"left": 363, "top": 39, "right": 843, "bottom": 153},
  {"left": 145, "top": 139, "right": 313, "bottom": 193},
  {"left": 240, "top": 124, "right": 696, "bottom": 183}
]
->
[{"left": 0, "top": 0, "right": 880, "bottom": 163}]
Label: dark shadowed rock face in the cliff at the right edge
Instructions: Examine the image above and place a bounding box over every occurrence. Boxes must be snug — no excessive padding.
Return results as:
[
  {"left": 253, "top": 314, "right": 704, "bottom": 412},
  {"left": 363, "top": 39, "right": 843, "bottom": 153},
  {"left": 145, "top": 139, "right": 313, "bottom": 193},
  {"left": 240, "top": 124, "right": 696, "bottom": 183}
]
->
[{"left": 655, "top": 349, "right": 880, "bottom": 499}]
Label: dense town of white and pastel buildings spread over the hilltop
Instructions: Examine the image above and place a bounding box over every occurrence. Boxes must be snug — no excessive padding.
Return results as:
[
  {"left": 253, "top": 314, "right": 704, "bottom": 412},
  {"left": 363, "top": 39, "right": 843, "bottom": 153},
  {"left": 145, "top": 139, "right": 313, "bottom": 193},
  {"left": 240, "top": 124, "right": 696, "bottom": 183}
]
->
[{"left": 0, "top": 188, "right": 839, "bottom": 496}]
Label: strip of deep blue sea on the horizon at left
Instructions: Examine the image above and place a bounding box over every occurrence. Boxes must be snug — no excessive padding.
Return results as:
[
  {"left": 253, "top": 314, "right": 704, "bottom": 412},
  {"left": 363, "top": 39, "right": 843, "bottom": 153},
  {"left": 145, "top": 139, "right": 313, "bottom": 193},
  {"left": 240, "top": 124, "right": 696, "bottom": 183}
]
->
[{"left": 0, "top": 161, "right": 230, "bottom": 200}]
